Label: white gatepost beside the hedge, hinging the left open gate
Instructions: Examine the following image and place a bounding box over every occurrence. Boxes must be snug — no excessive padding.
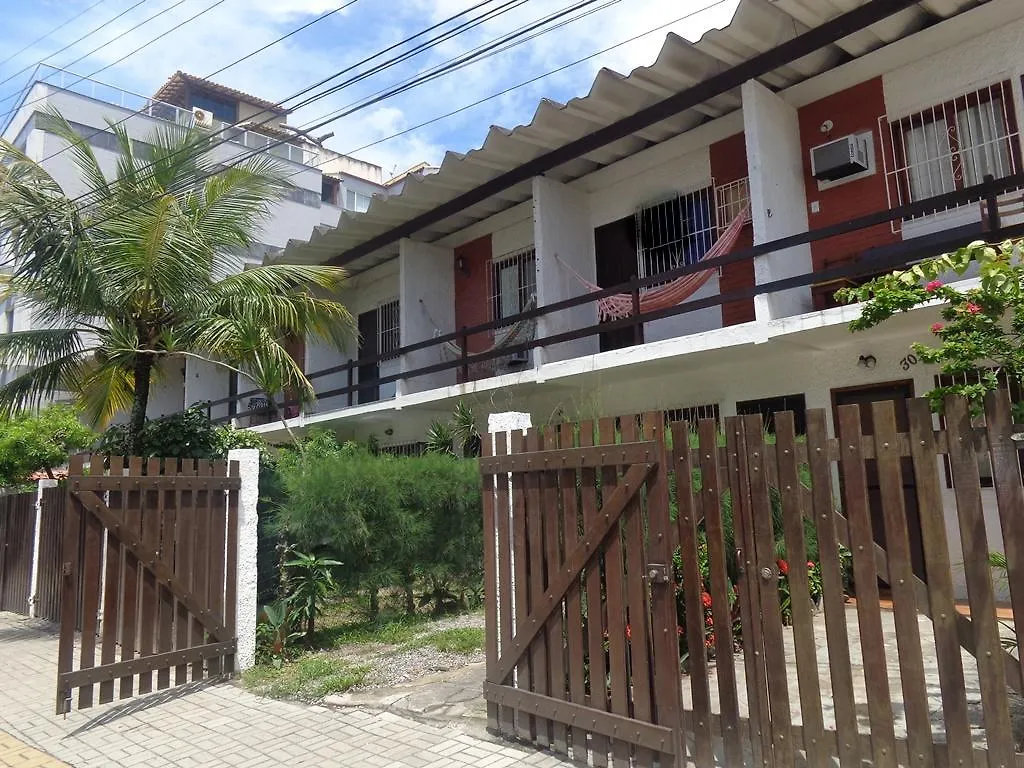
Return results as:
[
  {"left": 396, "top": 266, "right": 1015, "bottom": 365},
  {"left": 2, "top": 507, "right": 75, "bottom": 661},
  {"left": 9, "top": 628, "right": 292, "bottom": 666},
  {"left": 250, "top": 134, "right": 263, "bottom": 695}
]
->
[{"left": 227, "top": 449, "right": 259, "bottom": 672}]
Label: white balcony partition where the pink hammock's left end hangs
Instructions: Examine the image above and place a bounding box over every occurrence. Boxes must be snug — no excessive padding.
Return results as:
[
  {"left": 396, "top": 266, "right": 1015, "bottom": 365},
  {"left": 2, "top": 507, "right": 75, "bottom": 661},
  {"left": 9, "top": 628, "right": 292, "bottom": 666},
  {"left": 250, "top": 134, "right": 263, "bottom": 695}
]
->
[{"left": 534, "top": 176, "right": 600, "bottom": 366}]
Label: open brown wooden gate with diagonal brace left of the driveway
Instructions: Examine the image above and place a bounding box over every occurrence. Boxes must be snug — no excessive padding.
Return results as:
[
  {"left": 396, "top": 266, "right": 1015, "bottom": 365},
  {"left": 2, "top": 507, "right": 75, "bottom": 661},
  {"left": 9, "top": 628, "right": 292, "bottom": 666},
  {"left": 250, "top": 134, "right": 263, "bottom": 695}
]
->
[{"left": 56, "top": 456, "right": 240, "bottom": 714}]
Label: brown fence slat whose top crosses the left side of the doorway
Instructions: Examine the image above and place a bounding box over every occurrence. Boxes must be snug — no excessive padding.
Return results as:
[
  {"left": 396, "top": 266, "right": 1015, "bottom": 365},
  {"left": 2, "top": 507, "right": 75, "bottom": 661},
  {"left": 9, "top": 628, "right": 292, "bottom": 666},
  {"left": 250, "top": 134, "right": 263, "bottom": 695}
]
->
[{"left": 838, "top": 406, "right": 896, "bottom": 768}]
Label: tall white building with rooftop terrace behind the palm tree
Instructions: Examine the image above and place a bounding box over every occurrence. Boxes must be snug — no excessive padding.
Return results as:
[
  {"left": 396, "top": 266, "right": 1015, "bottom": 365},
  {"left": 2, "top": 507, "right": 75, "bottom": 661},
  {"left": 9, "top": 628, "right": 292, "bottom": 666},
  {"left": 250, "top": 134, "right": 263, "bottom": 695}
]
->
[{"left": 0, "top": 66, "right": 388, "bottom": 417}]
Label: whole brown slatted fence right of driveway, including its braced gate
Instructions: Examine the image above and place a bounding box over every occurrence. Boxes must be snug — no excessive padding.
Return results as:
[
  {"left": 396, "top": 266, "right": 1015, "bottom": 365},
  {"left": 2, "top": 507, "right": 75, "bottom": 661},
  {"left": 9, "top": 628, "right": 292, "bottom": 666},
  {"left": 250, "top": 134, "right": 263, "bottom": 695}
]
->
[{"left": 481, "top": 395, "right": 1024, "bottom": 768}]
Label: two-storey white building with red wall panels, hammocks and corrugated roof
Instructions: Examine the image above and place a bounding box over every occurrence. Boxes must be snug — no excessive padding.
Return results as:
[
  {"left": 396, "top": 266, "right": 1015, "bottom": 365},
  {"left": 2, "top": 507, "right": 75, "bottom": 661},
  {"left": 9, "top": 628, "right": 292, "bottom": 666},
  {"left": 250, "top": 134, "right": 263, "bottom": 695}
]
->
[{"left": 212, "top": 0, "right": 1024, "bottom": 602}]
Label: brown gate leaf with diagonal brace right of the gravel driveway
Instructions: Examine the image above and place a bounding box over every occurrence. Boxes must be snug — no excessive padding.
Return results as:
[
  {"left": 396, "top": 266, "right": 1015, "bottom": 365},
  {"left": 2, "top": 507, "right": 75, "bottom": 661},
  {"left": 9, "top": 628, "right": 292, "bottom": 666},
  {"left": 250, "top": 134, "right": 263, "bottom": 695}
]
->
[{"left": 480, "top": 414, "right": 682, "bottom": 765}]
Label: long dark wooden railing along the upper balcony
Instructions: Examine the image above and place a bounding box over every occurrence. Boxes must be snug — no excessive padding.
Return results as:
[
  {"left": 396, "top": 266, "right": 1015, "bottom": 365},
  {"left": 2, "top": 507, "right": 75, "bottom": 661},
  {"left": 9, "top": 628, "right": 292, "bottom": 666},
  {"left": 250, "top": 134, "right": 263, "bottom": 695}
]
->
[{"left": 197, "top": 173, "right": 1024, "bottom": 430}]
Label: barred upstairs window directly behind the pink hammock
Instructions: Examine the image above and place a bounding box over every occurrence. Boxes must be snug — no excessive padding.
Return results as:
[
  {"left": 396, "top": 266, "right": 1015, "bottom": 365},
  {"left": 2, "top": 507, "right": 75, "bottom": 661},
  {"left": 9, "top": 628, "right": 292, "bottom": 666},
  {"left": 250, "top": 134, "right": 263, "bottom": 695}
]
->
[{"left": 635, "top": 186, "right": 718, "bottom": 286}]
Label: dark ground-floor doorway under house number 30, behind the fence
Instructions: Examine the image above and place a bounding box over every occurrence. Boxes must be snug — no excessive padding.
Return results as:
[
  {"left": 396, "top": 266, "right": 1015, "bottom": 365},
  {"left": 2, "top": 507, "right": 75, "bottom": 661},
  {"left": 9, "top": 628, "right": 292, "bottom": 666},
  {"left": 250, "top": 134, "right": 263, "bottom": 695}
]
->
[{"left": 831, "top": 380, "right": 925, "bottom": 580}]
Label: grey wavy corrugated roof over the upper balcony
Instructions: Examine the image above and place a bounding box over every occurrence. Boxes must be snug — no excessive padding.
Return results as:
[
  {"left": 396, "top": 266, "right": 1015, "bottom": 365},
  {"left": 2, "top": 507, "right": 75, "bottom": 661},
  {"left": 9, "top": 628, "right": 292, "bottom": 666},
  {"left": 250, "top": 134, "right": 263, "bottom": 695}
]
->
[{"left": 278, "top": 0, "right": 986, "bottom": 271}]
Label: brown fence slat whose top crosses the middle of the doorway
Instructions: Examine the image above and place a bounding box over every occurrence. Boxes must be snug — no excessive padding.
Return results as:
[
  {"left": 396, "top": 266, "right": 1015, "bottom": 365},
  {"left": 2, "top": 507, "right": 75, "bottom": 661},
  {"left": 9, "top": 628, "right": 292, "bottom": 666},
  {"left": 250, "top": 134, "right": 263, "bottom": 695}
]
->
[{"left": 871, "top": 400, "right": 932, "bottom": 768}]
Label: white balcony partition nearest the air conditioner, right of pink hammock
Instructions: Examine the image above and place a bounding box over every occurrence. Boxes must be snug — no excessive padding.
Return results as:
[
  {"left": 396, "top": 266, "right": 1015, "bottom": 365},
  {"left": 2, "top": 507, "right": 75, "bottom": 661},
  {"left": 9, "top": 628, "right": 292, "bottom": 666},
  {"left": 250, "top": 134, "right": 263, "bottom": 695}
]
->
[{"left": 742, "top": 80, "right": 813, "bottom": 322}]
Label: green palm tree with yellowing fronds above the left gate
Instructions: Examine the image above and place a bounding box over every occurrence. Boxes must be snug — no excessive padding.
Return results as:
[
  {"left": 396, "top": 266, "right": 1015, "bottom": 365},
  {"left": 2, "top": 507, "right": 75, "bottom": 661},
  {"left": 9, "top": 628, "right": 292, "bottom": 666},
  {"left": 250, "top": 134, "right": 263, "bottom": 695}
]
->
[{"left": 0, "top": 111, "right": 353, "bottom": 453}]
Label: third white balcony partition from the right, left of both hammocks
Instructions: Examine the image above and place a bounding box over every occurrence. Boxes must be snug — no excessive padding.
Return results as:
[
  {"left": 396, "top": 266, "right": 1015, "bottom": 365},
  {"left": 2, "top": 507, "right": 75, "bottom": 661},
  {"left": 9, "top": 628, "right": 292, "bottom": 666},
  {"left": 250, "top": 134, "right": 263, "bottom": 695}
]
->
[{"left": 398, "top": 238, "right": 456, "bottom": 394}]
